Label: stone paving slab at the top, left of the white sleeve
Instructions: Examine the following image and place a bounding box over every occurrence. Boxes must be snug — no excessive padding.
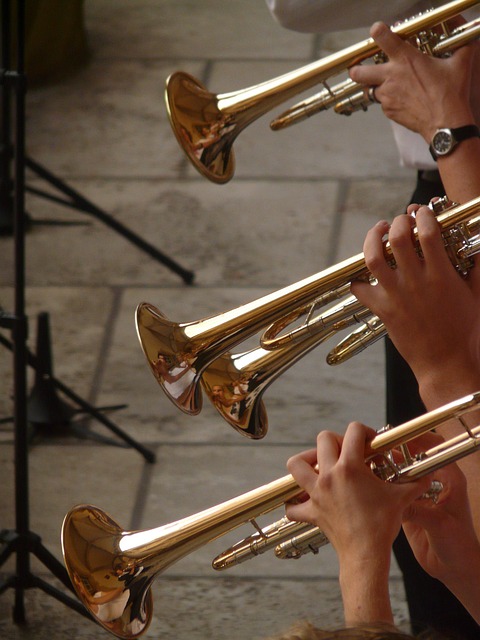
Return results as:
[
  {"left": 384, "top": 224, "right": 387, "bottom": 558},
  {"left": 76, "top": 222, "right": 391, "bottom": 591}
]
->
[{"left": 85, "top": 0, "right": 313, "bottom": 59}]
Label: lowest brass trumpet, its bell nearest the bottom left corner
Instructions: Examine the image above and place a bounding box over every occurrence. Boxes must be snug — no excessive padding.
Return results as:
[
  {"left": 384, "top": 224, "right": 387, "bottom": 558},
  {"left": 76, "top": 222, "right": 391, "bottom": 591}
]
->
[{"left": 62, "top": 393, "right": 480, "bottom": 639}]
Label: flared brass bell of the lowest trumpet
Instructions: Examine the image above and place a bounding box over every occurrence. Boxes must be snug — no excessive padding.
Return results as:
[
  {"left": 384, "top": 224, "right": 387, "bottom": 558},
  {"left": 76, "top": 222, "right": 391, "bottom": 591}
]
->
[{"left": 62, "top": 505, "right": 153, "bottom": 639}]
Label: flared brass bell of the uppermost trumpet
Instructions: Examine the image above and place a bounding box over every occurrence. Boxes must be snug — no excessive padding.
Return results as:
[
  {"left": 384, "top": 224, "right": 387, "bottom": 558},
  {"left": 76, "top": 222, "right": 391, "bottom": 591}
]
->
[{"left": 165, "top": 71, "right": 236, "bottom": 184}]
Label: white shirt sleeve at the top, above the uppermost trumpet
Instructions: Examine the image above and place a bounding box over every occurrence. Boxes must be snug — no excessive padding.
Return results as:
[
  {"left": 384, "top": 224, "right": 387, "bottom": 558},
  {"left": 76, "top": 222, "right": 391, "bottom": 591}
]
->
[{"left": 265, "top": 0, "right": 442, "bottom": 33}]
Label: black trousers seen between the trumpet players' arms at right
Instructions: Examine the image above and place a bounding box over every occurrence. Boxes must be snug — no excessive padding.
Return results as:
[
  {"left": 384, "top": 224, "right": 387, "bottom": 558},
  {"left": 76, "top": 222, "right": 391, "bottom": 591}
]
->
[{"left": 385, "top": 172, "right": 480, "bottom": 640}]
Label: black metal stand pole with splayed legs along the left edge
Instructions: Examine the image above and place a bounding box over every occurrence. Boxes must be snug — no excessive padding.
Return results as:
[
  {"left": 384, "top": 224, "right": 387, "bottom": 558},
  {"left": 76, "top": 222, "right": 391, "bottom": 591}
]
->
[{"left": 0, "top": 0, "right": 94, "bottom": 623}]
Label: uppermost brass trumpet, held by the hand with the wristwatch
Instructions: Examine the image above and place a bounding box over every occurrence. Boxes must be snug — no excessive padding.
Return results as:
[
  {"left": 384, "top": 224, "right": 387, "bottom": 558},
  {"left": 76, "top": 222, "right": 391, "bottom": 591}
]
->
[{"left": 165, "top": 0, "right": 478, "bottom": 184}]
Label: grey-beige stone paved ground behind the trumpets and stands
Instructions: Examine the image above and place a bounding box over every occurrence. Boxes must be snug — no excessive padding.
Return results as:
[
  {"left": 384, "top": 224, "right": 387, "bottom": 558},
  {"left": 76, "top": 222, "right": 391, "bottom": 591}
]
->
[{"left": 0, "top": 0, "right": 414, "bottom": 640}]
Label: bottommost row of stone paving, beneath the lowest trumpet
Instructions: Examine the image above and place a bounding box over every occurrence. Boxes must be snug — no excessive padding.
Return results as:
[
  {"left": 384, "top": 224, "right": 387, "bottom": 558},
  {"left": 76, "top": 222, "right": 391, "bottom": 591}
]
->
[{"left": 0, "top": 575, "right": 407, "bottom": 640}]
